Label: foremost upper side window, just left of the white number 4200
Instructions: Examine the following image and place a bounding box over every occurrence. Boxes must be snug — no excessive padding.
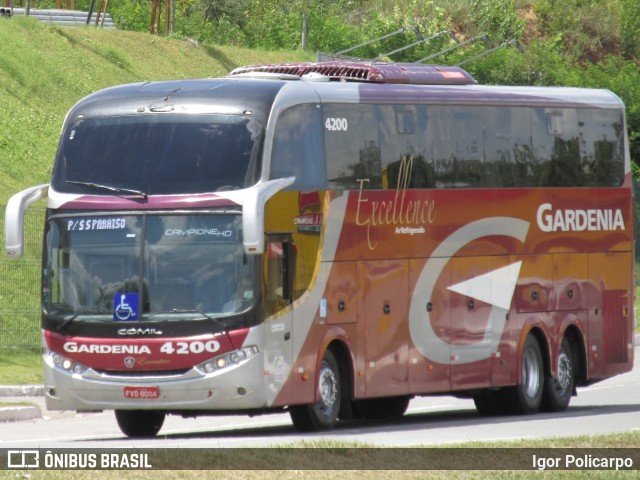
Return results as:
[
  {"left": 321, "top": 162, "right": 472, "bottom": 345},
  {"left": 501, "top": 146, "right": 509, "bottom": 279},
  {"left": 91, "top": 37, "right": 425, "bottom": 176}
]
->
[{"left": 269, "top": 104, "right": 327, "bottom": 190}]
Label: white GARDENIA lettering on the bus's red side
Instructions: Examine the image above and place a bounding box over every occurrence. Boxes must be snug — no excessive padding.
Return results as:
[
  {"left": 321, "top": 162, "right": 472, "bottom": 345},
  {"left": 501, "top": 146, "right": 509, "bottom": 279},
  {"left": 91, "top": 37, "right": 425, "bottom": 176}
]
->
[{"left": 537, "top": 203, "right": 625, "bottom": 232}]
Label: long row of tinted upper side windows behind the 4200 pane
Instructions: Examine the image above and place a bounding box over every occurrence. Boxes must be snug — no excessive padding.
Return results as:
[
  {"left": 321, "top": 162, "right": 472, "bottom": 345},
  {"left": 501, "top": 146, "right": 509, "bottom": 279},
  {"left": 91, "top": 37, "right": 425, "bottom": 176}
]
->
[{"left": 378, "top": 105, "right": 624, "bottom": 188}]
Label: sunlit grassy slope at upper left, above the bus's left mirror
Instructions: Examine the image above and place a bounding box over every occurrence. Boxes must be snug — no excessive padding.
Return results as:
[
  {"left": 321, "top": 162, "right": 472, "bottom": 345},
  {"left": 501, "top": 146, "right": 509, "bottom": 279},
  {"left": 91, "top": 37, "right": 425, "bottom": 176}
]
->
[{"left": 0, "top": 17, "right": 311, "bottom": 205}]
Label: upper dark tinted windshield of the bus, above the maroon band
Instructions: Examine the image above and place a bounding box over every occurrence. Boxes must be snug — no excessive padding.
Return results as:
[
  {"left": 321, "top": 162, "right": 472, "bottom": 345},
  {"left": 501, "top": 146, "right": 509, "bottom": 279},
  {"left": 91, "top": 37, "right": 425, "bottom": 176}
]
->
[{"left": 51, "top": 113, "right": 263, "bottom": 196}]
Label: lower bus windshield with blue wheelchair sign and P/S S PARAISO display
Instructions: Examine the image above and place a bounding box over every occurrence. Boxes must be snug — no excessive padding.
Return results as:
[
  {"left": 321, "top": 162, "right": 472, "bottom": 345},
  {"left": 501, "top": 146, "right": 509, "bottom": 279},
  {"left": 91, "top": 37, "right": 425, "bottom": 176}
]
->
[{"left": 43, "top": 214, "right": 256, "bottom": 322}]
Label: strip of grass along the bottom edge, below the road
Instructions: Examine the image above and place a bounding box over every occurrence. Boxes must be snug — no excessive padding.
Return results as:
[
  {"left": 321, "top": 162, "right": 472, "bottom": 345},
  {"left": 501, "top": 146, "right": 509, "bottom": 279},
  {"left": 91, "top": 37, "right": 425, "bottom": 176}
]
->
[{"left": 0, "top": 435, "right": 640, "bottom": 480}]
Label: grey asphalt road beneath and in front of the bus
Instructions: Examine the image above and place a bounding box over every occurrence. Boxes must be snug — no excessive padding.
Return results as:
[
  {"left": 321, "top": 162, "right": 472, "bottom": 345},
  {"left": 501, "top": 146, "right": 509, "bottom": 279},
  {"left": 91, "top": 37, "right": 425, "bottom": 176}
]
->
[{"left": 0, "top": 347, "right": 640, "bottom": 449}]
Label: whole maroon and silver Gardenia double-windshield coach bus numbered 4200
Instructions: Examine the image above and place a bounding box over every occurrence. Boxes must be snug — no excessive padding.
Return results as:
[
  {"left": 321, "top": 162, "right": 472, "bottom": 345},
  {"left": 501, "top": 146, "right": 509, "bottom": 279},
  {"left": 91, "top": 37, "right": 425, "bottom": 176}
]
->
[{"left": 5, "top": 61, "right": 634, "bottom": 437}]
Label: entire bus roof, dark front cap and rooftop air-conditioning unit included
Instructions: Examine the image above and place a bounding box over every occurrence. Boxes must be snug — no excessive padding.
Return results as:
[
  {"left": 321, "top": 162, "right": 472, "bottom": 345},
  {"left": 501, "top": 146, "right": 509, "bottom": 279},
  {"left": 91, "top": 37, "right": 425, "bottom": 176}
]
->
[{"left": 69, "top": 62, "right": 623, "bottom": 123}]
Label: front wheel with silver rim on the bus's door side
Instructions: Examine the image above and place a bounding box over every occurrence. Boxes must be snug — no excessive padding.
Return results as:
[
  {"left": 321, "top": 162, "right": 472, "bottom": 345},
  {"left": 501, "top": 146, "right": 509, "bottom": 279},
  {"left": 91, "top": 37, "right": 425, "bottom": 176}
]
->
[{"left": 289, "top": 350, "right": 342, "bottom": 432}]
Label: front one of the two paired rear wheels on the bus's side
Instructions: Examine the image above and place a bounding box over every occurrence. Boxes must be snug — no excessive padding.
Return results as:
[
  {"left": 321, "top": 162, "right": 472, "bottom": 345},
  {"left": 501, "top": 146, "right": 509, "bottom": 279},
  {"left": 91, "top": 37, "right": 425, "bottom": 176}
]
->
[{"left": 511, "top": 335, "right": 545, "bottom": 414}]
